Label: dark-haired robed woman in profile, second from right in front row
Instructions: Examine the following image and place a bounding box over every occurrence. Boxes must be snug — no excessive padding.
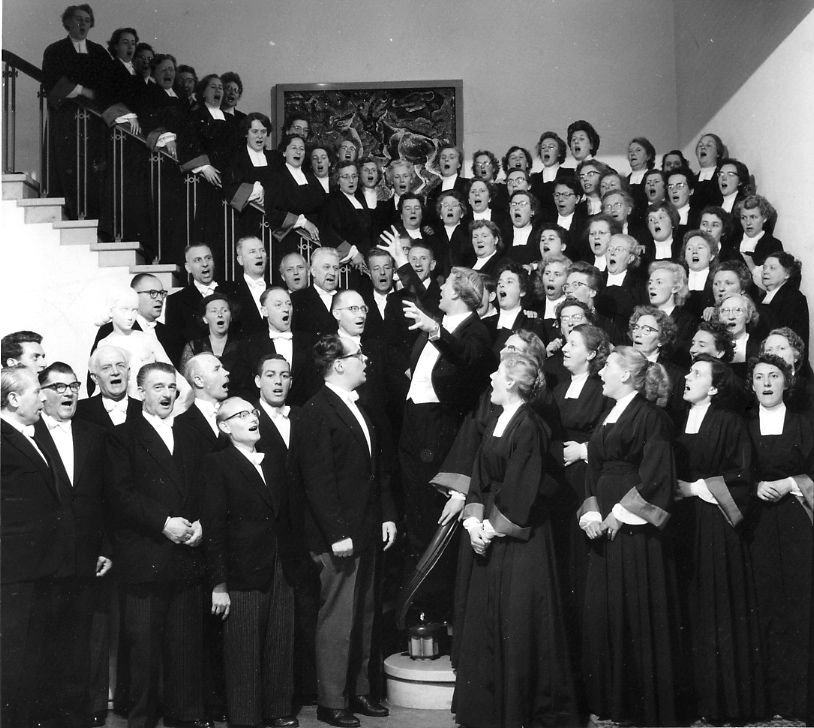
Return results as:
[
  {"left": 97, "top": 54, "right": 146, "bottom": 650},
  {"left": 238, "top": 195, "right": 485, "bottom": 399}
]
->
[{"left": 667, "top": 354, "right": 765, "bottom": 725}]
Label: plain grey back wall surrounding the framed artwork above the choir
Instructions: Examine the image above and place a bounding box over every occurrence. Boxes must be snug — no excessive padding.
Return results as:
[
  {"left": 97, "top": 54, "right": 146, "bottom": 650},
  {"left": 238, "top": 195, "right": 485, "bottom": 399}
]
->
[{"left": 3, "top": 0, "right": 678, "bottom": 175}]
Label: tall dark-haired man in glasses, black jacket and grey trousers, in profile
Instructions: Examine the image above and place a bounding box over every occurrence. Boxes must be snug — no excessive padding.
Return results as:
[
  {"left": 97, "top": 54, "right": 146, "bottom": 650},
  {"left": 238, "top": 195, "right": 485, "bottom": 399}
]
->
[{"left": 300, "top": 335, "right": 396, "bottom": 728}]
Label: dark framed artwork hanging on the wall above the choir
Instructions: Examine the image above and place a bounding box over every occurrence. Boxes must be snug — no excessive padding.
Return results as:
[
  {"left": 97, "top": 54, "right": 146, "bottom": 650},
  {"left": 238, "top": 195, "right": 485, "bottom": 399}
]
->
[{"left": 272, "top": 80, "right": 463, "bottom": 193}]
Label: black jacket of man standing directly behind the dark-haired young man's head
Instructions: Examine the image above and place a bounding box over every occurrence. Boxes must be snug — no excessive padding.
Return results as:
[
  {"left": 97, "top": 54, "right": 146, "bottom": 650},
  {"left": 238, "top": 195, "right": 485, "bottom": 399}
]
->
[{"left": 232, "top": 330, "right": 320, "bottom": 406}]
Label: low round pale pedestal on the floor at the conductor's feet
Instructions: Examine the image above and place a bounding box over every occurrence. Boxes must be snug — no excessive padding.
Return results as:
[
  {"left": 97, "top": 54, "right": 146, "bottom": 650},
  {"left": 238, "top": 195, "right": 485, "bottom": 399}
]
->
[{"left": 384, "top": 652, "right": 455, "bottom": 710}]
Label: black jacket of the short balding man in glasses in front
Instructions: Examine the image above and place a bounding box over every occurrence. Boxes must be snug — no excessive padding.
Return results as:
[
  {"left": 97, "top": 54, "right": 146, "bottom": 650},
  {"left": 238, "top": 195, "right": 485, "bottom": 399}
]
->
[{"left": 202, "top": 444, "right": 288, "bottom": 589}]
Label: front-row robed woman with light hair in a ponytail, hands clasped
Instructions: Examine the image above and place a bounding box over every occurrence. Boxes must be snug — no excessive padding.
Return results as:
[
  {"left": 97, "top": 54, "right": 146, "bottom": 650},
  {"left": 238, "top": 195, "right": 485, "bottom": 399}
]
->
[{"left": 578, "top": 346, "right": 676, "bottom": 726}]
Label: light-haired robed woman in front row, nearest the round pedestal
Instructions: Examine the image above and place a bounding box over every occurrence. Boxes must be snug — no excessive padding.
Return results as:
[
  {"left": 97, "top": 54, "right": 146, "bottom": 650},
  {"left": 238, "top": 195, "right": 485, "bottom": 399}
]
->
[{"left": 453, "top": 353, "right": 575, "bottom": 728}]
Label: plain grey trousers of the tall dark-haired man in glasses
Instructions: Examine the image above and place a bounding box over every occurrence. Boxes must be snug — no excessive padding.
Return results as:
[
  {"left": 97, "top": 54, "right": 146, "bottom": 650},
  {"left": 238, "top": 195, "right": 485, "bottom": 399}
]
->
[{"left": 311, "top": 546, "right": 375, "bottom": 709}]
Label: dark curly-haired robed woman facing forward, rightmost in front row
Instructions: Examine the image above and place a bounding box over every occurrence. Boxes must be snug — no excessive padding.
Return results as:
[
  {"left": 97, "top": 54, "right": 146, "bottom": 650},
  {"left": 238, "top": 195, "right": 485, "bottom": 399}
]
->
[{"left": 749, "top": 354, "right": 814, "bottom": 720}]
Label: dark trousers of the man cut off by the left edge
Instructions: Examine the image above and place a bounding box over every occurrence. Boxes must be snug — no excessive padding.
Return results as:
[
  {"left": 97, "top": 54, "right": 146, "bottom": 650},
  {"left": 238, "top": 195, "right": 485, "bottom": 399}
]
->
[{"left": 0, "top": 579, "right": 58, "bottom": 727}]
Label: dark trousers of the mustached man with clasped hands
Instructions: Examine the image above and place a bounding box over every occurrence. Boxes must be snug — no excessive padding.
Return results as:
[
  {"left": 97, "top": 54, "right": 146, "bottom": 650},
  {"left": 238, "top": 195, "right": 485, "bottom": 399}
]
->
[{"left": 121, "top": 582, "right": 204, "bottom": 728}]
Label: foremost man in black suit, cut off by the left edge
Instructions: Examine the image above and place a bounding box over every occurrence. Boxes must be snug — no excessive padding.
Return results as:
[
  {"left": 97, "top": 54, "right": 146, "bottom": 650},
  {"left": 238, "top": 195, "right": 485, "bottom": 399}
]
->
[{"left": 0, "top": 367, "right": 73, "bottom": 726}]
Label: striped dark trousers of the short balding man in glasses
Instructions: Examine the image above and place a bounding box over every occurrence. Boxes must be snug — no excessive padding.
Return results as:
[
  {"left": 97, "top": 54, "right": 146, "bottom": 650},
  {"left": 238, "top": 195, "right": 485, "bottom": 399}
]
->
[{"left": 223, "top": 560, "right": 294, "bottom": 725}]
